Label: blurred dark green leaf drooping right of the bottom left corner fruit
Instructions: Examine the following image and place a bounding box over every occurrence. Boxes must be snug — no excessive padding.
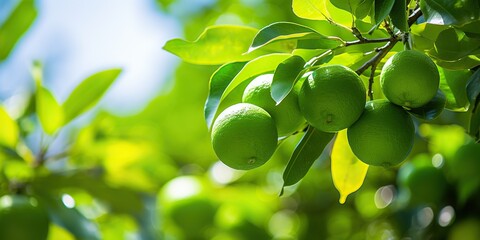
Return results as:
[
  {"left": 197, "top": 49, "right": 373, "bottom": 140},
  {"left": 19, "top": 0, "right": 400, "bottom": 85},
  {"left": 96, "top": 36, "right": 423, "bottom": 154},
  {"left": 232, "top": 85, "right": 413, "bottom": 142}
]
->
[{"left": 38, "top": 193, "right": 101, "bottom": 240}]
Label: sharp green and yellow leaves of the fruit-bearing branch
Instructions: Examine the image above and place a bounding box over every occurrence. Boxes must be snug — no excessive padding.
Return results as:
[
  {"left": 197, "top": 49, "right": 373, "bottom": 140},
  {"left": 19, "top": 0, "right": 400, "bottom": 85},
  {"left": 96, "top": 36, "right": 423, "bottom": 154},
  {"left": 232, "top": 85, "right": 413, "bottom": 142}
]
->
[{"left": 164, "top": 0, "right": 480, "bottom": 202}]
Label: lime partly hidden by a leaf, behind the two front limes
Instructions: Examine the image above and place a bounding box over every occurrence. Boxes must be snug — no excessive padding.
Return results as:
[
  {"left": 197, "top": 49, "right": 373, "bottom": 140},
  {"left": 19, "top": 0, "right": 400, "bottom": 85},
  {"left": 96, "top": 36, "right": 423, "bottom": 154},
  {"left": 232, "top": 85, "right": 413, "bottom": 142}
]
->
[{"left": 242, "top": 74, "right": 305, "bottom": 136}]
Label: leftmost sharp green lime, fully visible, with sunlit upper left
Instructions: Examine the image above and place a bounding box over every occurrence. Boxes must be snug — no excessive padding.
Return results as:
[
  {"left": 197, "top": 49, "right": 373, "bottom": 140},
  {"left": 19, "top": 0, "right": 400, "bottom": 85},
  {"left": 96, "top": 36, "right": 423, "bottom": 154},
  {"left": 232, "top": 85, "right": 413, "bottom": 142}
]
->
[{"left": 212, "top": 103, "right": 278, "bottom": 170}]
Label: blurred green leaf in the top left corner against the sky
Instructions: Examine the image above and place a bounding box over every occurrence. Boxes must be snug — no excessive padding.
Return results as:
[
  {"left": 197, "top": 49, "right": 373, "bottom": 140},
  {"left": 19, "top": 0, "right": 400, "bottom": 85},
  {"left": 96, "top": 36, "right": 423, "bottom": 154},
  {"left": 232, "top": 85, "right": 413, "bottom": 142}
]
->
[{"left": 0, "top": 0, "right": 37, "bottom": 61}]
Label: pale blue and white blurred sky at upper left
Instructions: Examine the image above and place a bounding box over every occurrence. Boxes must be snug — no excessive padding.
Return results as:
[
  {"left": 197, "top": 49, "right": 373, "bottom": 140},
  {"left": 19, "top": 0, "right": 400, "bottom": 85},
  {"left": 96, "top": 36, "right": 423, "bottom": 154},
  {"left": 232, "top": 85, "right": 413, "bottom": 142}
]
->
[{"left": 0, "top": 0, "right": 182, "bottom": 115}]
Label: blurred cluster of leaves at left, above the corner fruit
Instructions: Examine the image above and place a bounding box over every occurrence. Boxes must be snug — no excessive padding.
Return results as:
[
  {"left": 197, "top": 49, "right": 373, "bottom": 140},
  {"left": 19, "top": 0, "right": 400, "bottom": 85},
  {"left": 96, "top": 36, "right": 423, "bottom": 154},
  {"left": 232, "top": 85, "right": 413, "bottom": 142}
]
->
[{"left": 0, "top": 63, "right": 124, "bottom": 239}]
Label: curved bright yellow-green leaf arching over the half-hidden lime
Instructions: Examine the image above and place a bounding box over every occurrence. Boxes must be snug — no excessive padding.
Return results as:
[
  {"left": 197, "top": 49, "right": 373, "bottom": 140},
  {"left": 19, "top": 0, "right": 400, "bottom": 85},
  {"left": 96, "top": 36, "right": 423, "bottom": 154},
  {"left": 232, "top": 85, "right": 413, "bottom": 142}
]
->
[{"left": 220, "top": 53, "right": 292, "bottom": 102}]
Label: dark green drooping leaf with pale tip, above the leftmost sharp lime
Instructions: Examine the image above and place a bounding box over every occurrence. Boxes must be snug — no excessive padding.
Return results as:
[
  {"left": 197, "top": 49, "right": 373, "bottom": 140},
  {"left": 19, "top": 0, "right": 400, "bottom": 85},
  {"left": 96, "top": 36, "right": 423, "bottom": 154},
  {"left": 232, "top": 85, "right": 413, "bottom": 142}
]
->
[{"left": 204, "top": 62, "right": 247, "bottom": 128}]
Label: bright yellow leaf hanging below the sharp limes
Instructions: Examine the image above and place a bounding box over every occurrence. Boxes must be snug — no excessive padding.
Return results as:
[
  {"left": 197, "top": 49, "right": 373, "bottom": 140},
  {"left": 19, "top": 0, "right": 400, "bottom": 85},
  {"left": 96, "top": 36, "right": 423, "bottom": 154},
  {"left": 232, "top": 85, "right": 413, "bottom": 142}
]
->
[{"left": 331, "top": 129, "right": 368, "bottom": 204}]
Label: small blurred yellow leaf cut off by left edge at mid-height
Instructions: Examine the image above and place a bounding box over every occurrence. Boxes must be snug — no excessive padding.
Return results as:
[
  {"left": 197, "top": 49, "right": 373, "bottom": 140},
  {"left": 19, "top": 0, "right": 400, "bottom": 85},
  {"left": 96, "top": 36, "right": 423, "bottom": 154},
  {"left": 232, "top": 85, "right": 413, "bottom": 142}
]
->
[{"left": 0, "top": 106, "right": 20, "bottom": 148}]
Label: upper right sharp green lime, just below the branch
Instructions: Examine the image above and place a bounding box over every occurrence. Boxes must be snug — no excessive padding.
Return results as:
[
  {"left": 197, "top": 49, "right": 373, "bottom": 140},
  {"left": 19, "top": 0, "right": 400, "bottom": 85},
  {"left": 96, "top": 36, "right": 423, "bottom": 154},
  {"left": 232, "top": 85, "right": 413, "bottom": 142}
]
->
[{"left": 380, "top": 50, "right": 440, "bottom": 108}]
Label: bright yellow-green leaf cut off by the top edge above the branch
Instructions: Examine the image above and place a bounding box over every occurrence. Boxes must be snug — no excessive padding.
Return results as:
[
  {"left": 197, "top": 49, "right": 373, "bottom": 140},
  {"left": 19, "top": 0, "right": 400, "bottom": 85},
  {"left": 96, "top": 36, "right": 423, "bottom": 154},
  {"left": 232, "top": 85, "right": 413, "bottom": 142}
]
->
[{"left": 292, "top": 0, "right": 353, "bottom": 26}]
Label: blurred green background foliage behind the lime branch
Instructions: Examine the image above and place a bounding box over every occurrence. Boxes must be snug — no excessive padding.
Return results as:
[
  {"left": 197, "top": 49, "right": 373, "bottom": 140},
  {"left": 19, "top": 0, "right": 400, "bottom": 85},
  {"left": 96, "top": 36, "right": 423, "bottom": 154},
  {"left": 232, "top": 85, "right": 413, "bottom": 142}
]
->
[{"left": 0, "top": 0, "right": 480, "bottom": 240}]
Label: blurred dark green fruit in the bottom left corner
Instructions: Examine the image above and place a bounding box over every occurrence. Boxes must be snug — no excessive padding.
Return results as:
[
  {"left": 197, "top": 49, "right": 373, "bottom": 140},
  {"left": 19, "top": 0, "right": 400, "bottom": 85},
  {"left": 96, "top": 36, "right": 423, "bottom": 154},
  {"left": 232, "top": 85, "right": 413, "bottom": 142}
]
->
[{"left": 0, "top": 195, "right": 50, "bottom": 240}]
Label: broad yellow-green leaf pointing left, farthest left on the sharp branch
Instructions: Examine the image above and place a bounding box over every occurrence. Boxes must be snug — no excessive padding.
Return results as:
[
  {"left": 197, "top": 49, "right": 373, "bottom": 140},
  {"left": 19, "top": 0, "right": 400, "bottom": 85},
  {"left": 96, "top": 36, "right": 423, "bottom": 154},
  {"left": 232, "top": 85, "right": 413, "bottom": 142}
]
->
[{"left": 163, "top": 26, "right": 274, "bottom": 65}]
